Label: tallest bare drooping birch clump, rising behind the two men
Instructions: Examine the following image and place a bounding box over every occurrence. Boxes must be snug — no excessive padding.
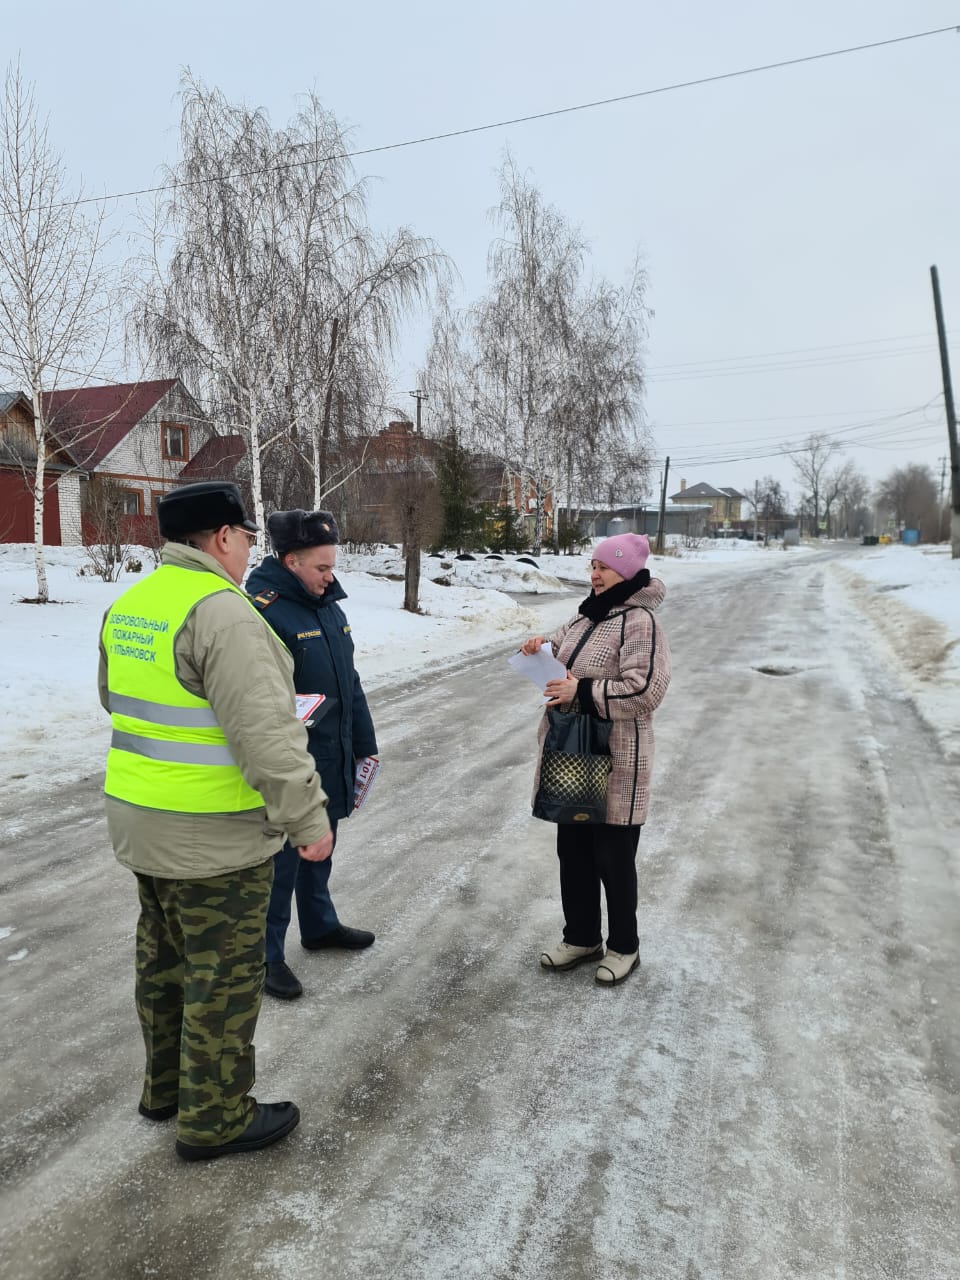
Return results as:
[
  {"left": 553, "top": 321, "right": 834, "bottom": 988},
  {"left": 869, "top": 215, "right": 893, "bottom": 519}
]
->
[{"left": 134, "top": 76, "right": 443, "bottom": 535}]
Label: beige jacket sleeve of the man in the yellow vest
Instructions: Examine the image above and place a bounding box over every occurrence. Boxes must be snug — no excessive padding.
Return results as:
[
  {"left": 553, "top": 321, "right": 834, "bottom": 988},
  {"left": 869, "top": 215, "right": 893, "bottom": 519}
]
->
[{"left": 174, "top": 591, "right": 330, "bottom": 845}]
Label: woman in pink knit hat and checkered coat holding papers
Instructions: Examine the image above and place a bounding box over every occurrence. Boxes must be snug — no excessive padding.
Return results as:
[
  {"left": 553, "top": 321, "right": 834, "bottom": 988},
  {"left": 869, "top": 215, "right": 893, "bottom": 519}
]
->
[{"left": 522, "top": 534, "right": 671, "bottom": 986}]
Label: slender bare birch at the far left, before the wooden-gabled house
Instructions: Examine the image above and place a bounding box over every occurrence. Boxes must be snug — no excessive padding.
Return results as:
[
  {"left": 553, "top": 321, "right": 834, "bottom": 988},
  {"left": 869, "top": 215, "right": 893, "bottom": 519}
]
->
[{"left": 0, "top": 65, "right": 111, "bottom": 603}]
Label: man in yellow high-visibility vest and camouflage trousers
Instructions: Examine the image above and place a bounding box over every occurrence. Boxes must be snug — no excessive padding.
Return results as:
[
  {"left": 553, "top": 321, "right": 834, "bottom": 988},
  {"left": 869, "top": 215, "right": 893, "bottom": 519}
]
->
[{"left": 100, "top": 481, "right": 333, "bottom": 1160}]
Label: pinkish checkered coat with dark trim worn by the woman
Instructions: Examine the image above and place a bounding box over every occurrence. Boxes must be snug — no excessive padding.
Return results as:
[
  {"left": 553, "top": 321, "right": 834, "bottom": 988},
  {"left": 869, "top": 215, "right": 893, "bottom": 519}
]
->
[{"left": 534, "top": 579, "right": 671, "bottom": 827}]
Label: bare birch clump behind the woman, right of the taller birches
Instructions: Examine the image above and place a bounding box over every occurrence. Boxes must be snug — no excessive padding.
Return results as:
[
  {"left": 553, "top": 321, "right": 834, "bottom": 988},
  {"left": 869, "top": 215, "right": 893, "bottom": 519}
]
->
[{"left": 424, "top": 156, "right": 650, "bottom": 550}]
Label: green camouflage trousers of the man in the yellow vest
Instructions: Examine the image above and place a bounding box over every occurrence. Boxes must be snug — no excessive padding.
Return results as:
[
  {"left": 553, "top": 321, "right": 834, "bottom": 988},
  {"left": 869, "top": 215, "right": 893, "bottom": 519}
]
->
[{"left": 136, "top": 858, "right": 274, "bottom": 1146}]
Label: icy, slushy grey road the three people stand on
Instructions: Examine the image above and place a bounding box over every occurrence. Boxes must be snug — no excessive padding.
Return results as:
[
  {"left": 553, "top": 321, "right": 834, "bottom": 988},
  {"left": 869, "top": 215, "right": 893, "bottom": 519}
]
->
[{"left": 0, "top": 553, "right": 960, "bottom": 1280}]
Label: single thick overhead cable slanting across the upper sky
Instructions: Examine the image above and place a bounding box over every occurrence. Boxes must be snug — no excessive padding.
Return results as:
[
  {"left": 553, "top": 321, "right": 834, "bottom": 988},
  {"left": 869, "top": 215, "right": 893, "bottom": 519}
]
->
[{"left": 62, "top": 27, "right": 960, "bottom": 209}]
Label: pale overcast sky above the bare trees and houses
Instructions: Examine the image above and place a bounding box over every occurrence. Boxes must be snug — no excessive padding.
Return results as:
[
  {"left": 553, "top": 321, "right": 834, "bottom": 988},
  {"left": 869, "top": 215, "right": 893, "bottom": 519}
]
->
[{"left": 3, "top": 0, "right": 960, "bottom": 504}]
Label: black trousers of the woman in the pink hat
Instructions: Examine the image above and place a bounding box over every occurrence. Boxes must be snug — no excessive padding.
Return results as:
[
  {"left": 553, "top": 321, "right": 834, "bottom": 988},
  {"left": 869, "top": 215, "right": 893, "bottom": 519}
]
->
[{"left": 557, "top": 823, "right": 640, "bottom": 955}]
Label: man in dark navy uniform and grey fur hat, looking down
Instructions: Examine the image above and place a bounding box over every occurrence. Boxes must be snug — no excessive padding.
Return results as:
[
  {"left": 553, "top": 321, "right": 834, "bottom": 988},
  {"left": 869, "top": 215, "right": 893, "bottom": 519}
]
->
[{"left": 247, "top": 511, "right": 379, "bottom": 1000}]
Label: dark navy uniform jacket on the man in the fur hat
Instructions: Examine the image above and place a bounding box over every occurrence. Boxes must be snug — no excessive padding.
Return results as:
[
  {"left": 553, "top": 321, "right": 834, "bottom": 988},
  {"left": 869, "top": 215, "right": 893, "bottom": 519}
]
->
[{"left": 247, "top": 556, "right": 379, "bottom": 818}]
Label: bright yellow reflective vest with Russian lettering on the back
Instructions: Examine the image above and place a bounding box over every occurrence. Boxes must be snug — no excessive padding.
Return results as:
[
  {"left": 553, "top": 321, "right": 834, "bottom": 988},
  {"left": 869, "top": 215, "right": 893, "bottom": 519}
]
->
[{"left": 101, "top": 564, "right": 266, "bottom": 813}]
